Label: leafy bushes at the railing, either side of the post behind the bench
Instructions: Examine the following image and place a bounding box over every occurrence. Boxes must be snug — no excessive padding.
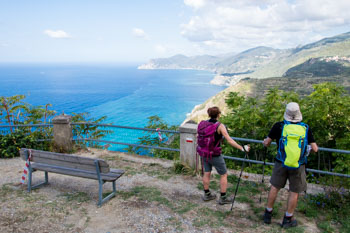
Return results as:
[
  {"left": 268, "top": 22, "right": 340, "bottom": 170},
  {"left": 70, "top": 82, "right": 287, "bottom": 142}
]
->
[{"left": 0, "top": 95, "right": 112, "bottom": 158}]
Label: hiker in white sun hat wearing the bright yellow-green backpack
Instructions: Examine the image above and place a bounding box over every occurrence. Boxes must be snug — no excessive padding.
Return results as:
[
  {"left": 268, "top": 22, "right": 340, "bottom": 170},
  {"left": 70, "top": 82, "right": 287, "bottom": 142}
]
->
[{"left": 263, "top": 102, "right": 318, "bottom": 228}]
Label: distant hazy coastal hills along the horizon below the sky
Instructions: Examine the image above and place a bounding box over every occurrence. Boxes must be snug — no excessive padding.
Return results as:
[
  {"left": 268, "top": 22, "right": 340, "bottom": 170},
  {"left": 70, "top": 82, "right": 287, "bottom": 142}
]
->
[{"left": 139, "top": 32, "right": 350, "bottom": 86}]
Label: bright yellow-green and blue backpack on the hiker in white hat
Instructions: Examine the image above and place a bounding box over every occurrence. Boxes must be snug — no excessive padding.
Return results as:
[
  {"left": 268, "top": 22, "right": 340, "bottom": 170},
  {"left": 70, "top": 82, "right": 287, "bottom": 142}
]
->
[{"left": 277, "top": 120, "right": 309, "bottom": 169}]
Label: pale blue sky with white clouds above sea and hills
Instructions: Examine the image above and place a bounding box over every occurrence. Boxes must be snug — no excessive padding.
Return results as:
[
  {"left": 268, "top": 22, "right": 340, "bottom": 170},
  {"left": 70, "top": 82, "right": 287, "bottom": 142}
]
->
[{"left": 0, "top": 0, "right": 350, "bottom": 63}]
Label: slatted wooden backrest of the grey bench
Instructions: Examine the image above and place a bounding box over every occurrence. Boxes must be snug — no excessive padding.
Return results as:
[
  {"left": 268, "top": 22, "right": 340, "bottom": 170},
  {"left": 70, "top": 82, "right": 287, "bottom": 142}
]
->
[{"left": 20, "top": 148, "right": 110, "bottom": 173}]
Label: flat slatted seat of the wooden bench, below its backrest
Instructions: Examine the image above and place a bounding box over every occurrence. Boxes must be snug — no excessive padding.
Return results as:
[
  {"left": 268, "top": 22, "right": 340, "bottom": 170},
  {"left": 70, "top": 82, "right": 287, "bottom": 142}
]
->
[{"left": 32, "top": 163, "right": 124, "bottom": 181}]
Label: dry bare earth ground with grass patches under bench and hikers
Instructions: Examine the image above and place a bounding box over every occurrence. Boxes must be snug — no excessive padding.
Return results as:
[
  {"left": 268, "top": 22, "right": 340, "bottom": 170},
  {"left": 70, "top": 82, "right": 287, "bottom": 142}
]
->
[{"left": 0, "top": 149, "right": 319, "bottom": 233}]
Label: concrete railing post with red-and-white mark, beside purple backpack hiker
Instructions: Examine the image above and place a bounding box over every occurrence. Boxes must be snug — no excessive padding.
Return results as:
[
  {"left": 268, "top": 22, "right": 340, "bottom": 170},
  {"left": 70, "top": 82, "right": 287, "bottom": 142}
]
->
[{"left": 179, "top": 123, "right": 199, "bottom": 169}]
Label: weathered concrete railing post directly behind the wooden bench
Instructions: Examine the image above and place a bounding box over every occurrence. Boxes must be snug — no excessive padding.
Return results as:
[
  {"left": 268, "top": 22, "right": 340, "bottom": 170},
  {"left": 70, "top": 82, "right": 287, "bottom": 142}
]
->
[{"left": 52, "top": 114, "right": 73, "bottom": 152}]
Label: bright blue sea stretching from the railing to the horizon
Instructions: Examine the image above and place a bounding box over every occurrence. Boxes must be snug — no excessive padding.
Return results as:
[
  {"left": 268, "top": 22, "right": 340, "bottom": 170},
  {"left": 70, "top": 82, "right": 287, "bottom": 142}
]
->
[{"left": 0, "top": 64, "right": 223, "bottom": 127}]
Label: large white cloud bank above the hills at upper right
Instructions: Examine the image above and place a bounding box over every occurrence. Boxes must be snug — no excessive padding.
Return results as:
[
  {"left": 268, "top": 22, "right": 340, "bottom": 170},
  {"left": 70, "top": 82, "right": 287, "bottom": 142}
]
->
[{"left": 181, "top": 0, "right": 350, "bottom": 52}]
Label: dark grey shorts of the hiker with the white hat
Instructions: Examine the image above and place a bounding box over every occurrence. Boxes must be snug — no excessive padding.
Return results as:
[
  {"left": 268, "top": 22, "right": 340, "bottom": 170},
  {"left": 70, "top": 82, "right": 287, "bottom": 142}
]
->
[{"left": 270, "top": 161, "right": 307, "bottom": 193}]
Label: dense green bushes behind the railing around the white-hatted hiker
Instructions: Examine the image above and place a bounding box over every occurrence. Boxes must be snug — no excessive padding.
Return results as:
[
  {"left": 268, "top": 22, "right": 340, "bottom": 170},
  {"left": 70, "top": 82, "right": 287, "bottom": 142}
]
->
[{"left": 221, "top": 83, "right": 350, "bottom": 174}]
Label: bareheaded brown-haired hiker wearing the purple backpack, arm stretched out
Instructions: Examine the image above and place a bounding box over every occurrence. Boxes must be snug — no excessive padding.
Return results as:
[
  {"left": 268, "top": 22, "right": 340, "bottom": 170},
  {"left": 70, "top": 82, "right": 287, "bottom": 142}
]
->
[{"left": 201, "top": 107, "right": 250, "bottom": 205}]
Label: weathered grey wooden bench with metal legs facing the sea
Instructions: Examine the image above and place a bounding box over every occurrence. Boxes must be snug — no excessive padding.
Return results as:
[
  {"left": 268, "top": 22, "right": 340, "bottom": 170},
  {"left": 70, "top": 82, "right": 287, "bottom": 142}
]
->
[{"left": 20, "top": 148, "right": 124, "bottom": 206}]
